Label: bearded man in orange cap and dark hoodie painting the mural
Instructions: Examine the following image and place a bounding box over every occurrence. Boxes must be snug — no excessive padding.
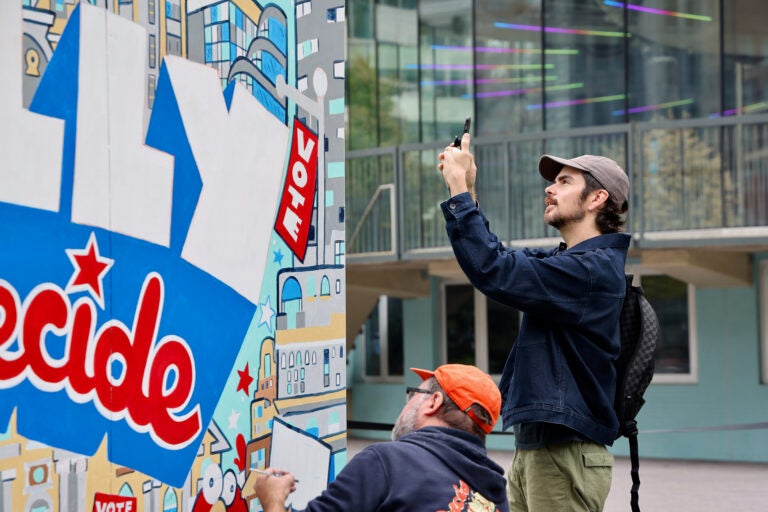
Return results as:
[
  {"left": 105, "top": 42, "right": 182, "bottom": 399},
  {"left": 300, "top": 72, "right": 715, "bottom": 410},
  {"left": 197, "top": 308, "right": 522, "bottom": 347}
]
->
[{"left": 249, "top": 364, "right": 509, "bottom": 512}]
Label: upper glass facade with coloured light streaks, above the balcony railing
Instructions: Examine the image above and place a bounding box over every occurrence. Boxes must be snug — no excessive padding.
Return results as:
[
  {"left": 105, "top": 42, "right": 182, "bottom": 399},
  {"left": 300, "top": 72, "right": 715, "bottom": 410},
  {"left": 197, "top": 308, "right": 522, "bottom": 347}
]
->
[{"left": 347, "top": 0, "right": 768, "bottom": 150}]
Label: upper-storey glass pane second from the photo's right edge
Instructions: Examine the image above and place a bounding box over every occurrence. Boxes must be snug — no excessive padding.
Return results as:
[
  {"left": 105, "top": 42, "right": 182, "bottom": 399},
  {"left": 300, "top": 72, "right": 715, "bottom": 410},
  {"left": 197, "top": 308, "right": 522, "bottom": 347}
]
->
[{"left": 632, "top": 0, "right": 720, "bottom": 121}]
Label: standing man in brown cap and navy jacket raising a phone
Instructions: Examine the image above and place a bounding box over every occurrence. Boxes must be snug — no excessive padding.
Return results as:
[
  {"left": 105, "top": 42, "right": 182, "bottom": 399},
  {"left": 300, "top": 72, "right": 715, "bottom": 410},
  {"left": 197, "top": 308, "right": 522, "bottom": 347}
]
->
[{"left": 438, "top": 134, "right": 630, "bottom": 512}]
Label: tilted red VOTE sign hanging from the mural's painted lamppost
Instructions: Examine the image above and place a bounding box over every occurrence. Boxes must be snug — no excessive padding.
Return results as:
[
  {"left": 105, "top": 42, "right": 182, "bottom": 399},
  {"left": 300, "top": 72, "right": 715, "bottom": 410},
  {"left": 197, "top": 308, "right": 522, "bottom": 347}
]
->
[{"left": 275, "top": 119, "right": 317, "bottom": 261}]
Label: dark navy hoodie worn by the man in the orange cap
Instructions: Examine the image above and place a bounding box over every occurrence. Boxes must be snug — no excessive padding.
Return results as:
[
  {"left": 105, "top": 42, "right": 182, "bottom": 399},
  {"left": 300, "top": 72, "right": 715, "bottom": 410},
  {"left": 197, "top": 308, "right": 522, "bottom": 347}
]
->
[{"left": 306, "top": 427, "right": 509, "bottom": 512}]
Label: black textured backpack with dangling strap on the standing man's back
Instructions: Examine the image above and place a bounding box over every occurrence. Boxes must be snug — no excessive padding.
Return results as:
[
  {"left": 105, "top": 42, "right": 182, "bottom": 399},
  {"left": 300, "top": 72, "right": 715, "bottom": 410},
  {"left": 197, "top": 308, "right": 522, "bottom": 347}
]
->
[{"left": 614, "top": 274, "right": 661, "bottom": 512}]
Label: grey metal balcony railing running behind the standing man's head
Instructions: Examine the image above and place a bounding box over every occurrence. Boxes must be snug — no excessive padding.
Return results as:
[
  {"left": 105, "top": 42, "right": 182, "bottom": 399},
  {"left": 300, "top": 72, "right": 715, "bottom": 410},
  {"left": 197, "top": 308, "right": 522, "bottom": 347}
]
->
[{"left": 346, "top": 115, "right": 768, "bottom": 261}]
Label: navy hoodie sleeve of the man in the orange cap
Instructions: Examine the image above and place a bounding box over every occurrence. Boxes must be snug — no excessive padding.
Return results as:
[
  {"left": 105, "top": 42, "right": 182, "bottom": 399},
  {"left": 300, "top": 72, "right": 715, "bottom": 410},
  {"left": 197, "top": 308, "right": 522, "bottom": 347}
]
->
[{"left": 304, "top": 447, "right": 390, "bottom": 512}]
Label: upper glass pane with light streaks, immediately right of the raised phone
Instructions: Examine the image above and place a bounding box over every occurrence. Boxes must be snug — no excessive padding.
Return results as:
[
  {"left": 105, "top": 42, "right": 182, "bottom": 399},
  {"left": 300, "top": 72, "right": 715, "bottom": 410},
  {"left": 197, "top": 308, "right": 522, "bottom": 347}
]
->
[{"left": 474, "top": 0, "right": 544, "bottom": 136}]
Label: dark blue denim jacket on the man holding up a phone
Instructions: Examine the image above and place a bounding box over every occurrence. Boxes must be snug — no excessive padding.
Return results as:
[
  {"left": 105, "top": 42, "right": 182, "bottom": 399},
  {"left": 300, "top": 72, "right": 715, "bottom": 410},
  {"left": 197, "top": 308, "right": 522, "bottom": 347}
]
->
[{"left": 440, "top": 193, "right": 630, "bottom": 445}]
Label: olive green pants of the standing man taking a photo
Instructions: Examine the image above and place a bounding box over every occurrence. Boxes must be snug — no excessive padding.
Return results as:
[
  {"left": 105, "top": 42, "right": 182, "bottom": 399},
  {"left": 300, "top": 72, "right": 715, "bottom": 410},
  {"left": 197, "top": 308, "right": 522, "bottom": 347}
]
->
[{"left": 507, "top": 442, "right": 613, "bottom": 512}]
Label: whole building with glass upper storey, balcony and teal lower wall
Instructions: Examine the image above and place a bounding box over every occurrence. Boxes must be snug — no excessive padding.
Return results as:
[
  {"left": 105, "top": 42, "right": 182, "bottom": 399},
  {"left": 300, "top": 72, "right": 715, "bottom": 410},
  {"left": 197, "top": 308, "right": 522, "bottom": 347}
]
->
[{"left": 345, "top": 0, "right": 768, "bottom": 468}]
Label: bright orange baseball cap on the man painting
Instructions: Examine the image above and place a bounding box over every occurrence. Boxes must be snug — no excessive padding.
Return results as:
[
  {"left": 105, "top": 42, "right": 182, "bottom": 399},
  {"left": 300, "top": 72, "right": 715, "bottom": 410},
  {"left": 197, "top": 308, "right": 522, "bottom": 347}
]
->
[{"left": 411, "top": 364, "right": 501, "bottom": 434}]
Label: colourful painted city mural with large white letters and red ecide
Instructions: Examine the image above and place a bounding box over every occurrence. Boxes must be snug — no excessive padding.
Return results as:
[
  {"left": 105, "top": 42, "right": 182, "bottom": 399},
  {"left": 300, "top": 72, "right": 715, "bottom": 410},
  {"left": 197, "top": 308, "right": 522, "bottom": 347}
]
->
[{"left": 0, "top": 0, "right": 346, "bottom": 512}]
